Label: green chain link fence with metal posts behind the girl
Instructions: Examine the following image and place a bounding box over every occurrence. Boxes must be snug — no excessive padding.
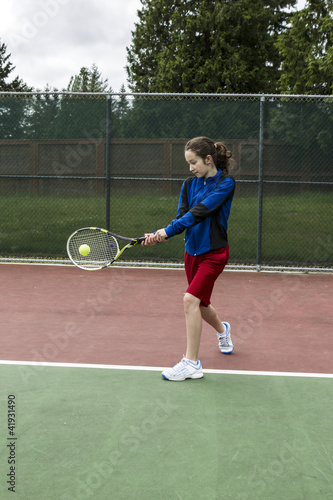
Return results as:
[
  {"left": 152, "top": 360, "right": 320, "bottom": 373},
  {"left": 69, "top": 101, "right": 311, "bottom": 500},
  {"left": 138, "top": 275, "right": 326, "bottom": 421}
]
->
[{"left": 0, "top": 92, "right": 333, "bottom": 270}]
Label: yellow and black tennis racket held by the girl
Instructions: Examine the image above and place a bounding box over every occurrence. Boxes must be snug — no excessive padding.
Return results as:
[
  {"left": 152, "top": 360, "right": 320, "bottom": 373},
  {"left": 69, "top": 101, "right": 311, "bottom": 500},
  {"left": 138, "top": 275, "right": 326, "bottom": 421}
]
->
[{"left": 67, "top": 227, "right": 145, "bottom": 271}]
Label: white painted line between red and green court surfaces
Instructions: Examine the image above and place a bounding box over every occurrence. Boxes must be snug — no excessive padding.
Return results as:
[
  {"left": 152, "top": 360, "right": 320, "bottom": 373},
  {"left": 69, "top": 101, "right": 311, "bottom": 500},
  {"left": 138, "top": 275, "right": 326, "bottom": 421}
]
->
[{"left": 0, "top": 360, "right": 333, "bottom": 378}]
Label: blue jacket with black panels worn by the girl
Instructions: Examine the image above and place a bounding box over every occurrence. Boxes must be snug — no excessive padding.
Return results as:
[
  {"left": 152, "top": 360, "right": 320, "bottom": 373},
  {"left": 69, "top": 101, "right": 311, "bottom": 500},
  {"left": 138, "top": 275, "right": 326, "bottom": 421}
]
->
[{"left": 165, "top": 170, "right": 235, "bottom": 255}]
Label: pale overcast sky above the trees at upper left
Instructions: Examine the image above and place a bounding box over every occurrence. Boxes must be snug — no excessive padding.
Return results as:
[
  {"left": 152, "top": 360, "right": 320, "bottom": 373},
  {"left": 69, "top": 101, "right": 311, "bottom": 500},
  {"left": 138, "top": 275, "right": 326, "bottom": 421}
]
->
[{"left": 0, "top": 0, "right": 306, "bottom": 92}]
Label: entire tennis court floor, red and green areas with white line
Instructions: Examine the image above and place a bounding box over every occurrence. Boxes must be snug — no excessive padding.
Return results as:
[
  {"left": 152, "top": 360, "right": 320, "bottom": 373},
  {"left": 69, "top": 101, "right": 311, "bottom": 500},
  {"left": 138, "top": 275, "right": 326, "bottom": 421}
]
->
[{"left": 0, "top": 264, "right": 333, "bottom": 500}]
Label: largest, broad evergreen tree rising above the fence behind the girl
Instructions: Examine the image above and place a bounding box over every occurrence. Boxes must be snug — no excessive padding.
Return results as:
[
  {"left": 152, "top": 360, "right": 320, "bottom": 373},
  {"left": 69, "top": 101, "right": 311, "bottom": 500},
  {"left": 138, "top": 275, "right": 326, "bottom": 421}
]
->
[{"left": 126, "top": 0, "right": 296, "bottom": 93}]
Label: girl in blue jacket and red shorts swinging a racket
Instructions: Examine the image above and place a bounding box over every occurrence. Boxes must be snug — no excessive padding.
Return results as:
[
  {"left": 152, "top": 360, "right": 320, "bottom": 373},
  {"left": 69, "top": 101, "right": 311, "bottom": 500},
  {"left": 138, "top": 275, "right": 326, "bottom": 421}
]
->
[{"left": 142, "top": 137, "right": 235, "bottom": 381}]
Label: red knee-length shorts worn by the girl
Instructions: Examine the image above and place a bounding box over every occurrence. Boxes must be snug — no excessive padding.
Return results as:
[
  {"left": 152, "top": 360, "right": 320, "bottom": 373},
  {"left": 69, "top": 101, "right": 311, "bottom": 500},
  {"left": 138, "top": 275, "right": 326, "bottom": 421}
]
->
[{"left": 185, "top": 247, "right": 229, "bottom": 307}]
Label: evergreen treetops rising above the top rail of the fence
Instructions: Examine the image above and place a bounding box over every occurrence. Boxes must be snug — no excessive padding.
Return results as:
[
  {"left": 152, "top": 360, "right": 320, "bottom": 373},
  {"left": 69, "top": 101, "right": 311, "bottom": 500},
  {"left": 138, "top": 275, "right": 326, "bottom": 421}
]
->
[{"left": 0, "top": 0, "right": 333, "bottom": 95}]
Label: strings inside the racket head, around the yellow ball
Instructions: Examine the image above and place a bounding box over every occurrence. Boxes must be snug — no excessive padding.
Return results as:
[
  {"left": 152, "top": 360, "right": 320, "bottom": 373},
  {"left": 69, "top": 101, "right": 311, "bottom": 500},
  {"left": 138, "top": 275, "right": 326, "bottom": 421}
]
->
[{"left": 68, "top": 229, "right": 119, "bottom": 269}]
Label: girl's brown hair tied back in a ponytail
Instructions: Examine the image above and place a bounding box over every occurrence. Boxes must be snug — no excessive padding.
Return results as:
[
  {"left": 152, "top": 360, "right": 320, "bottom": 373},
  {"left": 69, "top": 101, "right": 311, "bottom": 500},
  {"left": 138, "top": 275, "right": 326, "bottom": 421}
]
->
[{"left": 185, "top": 137, "right": 232, "bottom": 174}]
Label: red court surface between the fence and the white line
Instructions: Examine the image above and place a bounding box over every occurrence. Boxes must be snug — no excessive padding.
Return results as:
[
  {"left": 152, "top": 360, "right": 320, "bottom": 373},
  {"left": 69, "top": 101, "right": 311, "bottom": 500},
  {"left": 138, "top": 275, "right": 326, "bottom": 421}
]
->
[{"left": 0, "top": 264, "right": 333, "bottom": 373}]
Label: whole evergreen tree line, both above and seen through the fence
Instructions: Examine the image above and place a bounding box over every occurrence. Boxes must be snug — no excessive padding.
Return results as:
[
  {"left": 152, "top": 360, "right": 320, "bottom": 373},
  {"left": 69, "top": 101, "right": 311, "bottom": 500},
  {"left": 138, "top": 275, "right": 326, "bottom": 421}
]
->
[{"left": 0, "top": 0, "right": 333, "bottom": 163}]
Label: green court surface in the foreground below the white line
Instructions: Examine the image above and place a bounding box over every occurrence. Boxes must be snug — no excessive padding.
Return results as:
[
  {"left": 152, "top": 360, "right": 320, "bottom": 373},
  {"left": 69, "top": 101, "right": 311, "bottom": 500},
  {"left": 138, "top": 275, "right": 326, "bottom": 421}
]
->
[{"left": 0, "top": 364, "right": 333, "bottom": 500}]
